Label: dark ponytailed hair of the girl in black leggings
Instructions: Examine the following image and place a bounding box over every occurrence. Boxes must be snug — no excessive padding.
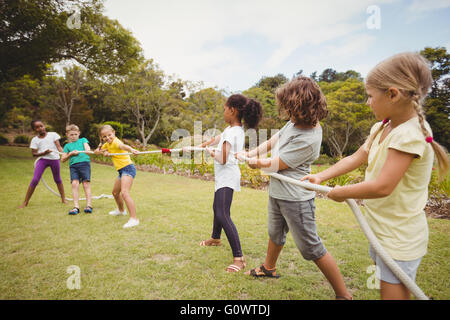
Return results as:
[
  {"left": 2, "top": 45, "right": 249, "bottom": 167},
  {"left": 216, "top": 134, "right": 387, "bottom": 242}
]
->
[{"left": 225, "top": 94, "right": 263, "bottom": 128}]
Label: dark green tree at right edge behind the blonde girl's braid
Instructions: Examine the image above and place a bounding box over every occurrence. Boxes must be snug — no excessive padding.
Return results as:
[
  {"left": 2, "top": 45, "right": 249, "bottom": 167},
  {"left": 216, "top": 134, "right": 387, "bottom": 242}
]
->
[{"left": 420, "top": 47, "right": 450, "bottom": 149}]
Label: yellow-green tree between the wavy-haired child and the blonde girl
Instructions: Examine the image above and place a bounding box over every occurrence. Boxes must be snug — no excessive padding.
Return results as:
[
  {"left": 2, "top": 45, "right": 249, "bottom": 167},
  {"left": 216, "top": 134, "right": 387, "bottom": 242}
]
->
[{"left": 319, "top": 78, "right": 375, "bottom": 158}]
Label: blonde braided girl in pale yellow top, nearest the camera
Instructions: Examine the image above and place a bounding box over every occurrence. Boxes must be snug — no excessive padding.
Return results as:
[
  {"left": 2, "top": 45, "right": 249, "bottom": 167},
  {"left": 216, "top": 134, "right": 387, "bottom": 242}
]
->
[{"left": 302, "top": 53, "right": 448, "bottom": 299}]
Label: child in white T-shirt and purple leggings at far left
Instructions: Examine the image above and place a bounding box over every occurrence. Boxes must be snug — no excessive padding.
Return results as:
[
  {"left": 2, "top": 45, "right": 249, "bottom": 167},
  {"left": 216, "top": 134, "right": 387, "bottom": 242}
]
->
[{"left": 19, "top": 120, "right": 68, "bottom": 208}]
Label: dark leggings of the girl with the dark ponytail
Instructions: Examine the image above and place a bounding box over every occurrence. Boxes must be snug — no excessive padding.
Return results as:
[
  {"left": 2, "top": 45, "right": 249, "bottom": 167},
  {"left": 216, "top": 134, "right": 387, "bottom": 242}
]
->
[{"left": 211, "top": 187, "right": 242, "bottom": 258}]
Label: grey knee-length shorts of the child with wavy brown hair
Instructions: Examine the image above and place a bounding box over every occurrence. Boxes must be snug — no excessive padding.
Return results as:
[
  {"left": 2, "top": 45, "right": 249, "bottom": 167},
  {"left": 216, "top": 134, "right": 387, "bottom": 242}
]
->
[{"left": 268, "top": 196, "right": 327, "bottom": 261}]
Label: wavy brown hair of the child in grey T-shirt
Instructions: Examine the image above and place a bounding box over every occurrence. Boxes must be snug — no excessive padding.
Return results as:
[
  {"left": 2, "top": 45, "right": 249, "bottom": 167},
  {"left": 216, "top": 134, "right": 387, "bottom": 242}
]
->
[{"left": 275, "top": 76, "right": 328, "bottom": 126}]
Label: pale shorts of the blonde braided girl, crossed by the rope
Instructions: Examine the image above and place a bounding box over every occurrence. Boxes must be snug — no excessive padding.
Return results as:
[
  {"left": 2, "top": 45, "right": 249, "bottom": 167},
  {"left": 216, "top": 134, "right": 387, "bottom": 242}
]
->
[{"left": 369, "top": 246, "right": 422, "bottom": 284}]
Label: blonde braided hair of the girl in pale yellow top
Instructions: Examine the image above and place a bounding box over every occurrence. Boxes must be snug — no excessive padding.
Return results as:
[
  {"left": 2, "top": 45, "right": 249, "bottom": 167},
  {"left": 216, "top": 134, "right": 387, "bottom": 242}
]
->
[{"left": 366, "top": 52, "right": 449, "bottom": 179}]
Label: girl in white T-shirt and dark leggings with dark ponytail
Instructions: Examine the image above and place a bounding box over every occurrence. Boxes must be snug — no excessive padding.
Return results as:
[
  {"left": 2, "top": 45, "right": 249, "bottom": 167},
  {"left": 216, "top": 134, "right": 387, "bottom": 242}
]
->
[{"left": 193, "top": 94, "right": 262, "bottom": 272}]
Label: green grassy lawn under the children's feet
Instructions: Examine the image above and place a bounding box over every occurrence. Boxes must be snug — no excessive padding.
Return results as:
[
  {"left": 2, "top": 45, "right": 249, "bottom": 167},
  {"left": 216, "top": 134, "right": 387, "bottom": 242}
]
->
[{"left": 0, "top": 147, "right": 450, "bottom": 300}]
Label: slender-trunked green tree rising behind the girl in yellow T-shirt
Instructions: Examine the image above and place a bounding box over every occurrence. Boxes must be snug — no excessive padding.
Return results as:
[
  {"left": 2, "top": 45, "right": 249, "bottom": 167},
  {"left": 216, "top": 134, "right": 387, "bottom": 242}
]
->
[{"left": 106, "top": 60, "right": 168, "bottom": 147}]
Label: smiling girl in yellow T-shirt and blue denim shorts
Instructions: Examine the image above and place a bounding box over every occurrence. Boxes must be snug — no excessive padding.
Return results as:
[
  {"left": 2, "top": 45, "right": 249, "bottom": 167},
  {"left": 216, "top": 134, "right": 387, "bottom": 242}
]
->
[{"left": 94, "top": 125, "right": 139, "bottom": 228}]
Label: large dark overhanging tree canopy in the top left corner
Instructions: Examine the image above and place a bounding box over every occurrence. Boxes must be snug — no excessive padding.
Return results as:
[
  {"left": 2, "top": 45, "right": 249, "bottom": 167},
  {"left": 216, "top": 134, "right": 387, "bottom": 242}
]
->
[{"left": 0, "top": 0, "right": 142, "bottom": 83}]
